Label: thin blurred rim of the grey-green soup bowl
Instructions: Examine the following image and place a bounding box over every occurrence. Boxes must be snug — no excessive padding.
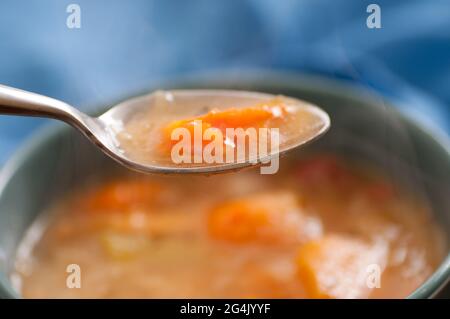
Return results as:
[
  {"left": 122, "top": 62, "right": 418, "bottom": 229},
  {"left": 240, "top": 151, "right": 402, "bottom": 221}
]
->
[{"left": 0, "top": 69, "right": 450, "bottom": 299}]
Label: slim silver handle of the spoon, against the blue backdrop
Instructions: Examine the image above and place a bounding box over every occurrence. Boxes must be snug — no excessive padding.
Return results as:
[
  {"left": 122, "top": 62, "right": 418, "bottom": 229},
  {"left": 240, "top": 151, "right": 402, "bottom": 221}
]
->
[{"left": 0, "top": 85, "right": 88, "bottom": 127}]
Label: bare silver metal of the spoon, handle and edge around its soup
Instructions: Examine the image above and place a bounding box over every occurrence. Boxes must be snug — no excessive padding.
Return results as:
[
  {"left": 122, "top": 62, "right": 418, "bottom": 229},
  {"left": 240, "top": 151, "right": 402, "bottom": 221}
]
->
[{"left": 0, "top": 85, "right": 330, "bottom": 174}]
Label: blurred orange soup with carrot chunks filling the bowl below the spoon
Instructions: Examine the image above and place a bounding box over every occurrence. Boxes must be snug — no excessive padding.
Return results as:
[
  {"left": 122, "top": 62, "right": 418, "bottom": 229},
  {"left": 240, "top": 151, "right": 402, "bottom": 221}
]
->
[{"left": 12, "top": 154, "right": 445, "bottom": 298}]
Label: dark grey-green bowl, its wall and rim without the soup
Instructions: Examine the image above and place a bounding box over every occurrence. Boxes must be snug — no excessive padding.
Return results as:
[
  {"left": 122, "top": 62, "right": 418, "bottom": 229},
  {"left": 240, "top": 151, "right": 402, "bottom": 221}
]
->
[{"left": 0, "top": 73, "right": 450, "bottom": 298}]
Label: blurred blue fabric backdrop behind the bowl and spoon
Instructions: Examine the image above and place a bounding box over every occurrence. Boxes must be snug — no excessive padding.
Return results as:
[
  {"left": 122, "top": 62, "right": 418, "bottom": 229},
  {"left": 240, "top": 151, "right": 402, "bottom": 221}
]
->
[{"left": 0, "top": 0, "right": 450, "bottom": 163}]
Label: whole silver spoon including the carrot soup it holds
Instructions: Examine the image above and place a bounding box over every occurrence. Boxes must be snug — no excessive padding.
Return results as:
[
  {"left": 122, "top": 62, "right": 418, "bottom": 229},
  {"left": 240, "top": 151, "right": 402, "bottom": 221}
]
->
[{"left": 0, "top": 86, "right": 330, "bottom": 174}]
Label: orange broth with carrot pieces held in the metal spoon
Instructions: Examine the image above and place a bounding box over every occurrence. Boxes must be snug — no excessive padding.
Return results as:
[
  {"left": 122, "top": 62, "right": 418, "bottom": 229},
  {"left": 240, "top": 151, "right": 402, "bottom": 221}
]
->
[{"left": 112, "top": 91, "right": 330, "bottom": 172}]
